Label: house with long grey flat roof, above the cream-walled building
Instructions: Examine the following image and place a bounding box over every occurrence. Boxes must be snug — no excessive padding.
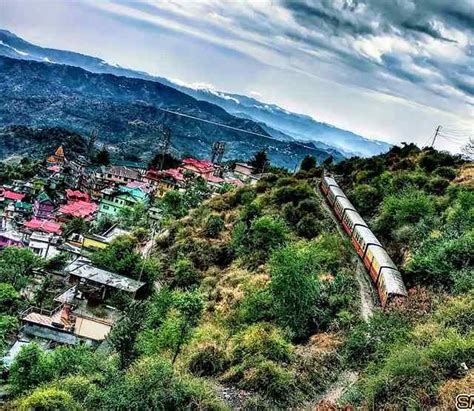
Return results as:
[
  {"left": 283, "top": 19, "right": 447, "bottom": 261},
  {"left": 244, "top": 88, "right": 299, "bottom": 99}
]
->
[{"left": 64, "top": 257, "right": 145, "bottom": 301}]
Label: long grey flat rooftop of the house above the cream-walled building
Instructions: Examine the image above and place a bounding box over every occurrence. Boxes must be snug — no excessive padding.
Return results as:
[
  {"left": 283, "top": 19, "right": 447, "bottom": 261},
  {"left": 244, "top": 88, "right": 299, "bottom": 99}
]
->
[{"left": 65, "top": 258, "right": 145, "bottom": 293}]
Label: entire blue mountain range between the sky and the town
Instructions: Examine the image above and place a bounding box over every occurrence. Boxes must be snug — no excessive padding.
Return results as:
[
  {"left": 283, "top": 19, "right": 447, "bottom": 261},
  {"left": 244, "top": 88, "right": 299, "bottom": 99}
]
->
[{"left": 0, "top": 30, "right": 390, "bottom": 168}]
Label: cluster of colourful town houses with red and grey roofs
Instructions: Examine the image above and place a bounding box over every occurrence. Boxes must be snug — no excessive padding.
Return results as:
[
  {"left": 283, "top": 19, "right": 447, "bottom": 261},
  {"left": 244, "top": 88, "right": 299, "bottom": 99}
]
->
[{"left": 0, "top": 147, "right": 258, "bottom": 365}]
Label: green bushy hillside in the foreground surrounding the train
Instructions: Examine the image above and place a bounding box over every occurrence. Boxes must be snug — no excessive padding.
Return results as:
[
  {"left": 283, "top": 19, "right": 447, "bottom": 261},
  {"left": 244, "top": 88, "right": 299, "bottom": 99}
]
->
[{"left": 0, "top": 145, "right": 474, "bottom": 410}]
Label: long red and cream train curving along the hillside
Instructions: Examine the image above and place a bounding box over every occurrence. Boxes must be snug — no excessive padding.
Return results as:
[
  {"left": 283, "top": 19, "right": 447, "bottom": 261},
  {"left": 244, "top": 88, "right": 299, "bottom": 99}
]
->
[{"left": 320, "top": 176, "right": 407, "bottom": 308}]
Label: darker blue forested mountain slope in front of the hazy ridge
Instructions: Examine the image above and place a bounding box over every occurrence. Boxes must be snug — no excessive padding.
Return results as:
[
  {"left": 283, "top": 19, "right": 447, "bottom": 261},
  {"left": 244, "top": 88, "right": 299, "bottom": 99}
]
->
[{"left": 0, "top": 57, "right": 342, "bottom": 168}]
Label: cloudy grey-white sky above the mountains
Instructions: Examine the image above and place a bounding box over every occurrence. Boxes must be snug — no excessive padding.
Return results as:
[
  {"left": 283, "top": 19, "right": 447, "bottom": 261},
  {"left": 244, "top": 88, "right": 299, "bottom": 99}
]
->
[{"left": 0, "top": 0, "right": 474, "bottom": 150}]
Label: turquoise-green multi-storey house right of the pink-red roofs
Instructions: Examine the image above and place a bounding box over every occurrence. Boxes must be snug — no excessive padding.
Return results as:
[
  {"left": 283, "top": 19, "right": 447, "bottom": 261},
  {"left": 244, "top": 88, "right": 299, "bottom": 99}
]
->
[{"left": 99, "top": 186, "right": 150, "bottom": 218}]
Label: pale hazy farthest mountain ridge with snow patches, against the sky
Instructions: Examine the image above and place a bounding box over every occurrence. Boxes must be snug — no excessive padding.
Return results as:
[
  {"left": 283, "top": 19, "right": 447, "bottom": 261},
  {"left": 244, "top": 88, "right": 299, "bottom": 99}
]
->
[{"left": 0, "top": 30, "right": 390, "bottom": 156}]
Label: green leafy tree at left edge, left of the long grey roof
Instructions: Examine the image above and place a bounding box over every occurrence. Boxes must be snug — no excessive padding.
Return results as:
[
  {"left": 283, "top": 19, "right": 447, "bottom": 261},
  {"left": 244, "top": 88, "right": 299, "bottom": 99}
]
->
[{"left": 0, "top": 247, "right": 42, "bottom": 290}]
